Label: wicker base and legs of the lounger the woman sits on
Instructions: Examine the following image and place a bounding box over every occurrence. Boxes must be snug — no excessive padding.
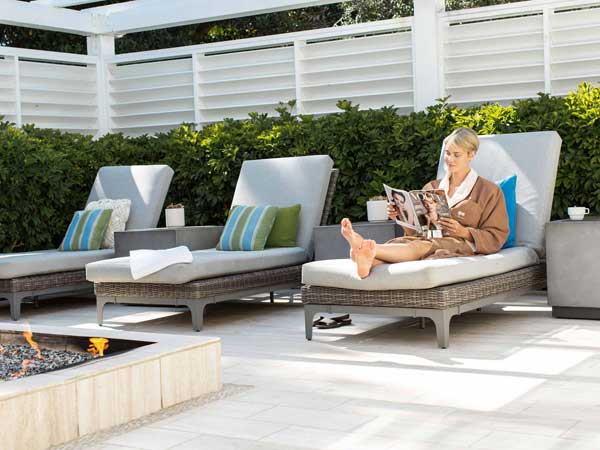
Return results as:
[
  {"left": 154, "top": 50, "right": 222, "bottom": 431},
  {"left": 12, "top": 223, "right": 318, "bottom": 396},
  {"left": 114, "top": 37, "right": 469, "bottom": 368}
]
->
[{"left": 302, "top": 264, "right": 546, "bottom": 348}]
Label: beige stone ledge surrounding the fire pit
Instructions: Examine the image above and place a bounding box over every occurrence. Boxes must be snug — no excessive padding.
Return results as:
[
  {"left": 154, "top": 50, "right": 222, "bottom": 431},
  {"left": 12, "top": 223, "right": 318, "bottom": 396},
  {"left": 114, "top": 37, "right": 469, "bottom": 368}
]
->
[{"left": 0, "top": 322, "right": 222, "bottom": 450}]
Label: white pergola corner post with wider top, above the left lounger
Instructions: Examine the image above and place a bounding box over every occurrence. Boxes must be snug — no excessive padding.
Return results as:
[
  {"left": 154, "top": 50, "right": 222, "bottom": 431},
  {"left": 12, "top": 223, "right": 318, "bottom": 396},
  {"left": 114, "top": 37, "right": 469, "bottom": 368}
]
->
[{"left": 87, "top": 34, "right": 115, "bottom": 137}]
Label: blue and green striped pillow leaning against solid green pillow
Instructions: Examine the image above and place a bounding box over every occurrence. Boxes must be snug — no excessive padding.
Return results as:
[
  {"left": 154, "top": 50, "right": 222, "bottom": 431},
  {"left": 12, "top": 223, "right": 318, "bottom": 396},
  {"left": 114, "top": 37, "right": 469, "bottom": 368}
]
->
[{"left": 217, "top": 205, "right": 277, "bottom": 251}]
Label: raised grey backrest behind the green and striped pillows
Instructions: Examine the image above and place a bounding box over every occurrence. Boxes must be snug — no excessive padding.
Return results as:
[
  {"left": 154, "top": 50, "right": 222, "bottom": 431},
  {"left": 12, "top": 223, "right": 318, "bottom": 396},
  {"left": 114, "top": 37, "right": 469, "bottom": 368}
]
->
[{"left": 232, "top": 155, "right": 333, "bottom": 258}]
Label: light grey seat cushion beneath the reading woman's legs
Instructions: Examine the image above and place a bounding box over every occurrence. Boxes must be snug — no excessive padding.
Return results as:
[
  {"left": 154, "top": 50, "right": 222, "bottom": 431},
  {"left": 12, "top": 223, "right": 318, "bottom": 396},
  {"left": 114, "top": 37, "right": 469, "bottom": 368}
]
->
[{"left": 302, "top": 247, "right": 539, "bottom": 291}]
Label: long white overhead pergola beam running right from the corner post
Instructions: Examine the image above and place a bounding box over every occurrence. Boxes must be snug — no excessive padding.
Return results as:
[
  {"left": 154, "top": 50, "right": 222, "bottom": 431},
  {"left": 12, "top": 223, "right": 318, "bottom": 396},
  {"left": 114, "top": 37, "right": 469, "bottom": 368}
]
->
[{"left": 95, "top": 0, "right": 342, "bottom": 34}]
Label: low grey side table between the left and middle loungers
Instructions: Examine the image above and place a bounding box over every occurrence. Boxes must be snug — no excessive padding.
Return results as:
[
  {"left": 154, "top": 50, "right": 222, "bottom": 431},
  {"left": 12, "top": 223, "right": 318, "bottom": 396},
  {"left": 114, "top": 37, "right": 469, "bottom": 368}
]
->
[{"left": 115, "top": 225, "right": 223, "bottom": 258}]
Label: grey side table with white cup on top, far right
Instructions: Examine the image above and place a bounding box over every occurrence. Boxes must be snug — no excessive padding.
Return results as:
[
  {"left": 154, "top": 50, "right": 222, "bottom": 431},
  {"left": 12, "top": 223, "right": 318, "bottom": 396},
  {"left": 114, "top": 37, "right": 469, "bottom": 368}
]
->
[{"left": 546, "top": 217, "right": 600, "bottom": 319}]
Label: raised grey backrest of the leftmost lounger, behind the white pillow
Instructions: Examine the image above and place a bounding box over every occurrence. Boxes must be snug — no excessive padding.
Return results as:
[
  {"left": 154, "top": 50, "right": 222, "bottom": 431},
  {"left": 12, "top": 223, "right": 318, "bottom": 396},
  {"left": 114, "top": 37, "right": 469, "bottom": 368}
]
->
[{"left": 87, "top": 165, "right": 173, "bottom": 230}]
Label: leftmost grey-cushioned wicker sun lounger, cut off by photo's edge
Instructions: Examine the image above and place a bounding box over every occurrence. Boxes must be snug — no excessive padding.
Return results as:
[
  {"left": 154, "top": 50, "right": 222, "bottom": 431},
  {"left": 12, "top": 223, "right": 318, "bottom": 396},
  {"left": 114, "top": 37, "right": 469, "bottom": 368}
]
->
[{"left": 0, "top": 165, "right": 173, "bottom": 320}]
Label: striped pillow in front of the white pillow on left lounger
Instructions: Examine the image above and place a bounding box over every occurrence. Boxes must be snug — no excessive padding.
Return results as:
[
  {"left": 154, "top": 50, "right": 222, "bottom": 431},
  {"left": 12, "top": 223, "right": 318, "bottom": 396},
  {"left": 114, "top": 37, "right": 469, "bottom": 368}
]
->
[{"left": 59, "top": 209, "right": 112, "bottom": 252}]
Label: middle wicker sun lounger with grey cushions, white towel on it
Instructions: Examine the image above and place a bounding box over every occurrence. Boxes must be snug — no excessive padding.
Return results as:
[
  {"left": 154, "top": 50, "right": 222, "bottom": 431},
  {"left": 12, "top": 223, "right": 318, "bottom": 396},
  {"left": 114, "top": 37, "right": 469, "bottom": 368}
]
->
[{"left": 86, "top": 155, "right": 337, "bottom": 331}]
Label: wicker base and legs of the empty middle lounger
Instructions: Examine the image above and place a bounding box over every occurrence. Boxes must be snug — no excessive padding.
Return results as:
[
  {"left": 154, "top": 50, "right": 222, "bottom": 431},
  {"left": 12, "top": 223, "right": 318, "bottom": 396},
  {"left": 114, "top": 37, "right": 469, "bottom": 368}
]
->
[{"left": 94, "top": 265, "right": 302, "bottom": 331}]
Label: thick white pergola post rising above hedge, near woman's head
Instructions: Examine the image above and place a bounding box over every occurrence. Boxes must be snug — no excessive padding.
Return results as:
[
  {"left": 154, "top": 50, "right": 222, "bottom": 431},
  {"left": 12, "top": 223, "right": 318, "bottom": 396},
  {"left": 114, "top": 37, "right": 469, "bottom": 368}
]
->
[{"left": 412, "top": 0, "right": 445, "bottom": 111}]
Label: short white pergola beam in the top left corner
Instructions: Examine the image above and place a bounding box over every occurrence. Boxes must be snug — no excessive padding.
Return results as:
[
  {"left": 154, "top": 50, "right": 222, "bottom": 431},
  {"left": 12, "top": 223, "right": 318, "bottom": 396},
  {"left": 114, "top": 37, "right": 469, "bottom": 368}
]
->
[{"left": 0, "top": 0, "right": 99, "bottom": 35}]
